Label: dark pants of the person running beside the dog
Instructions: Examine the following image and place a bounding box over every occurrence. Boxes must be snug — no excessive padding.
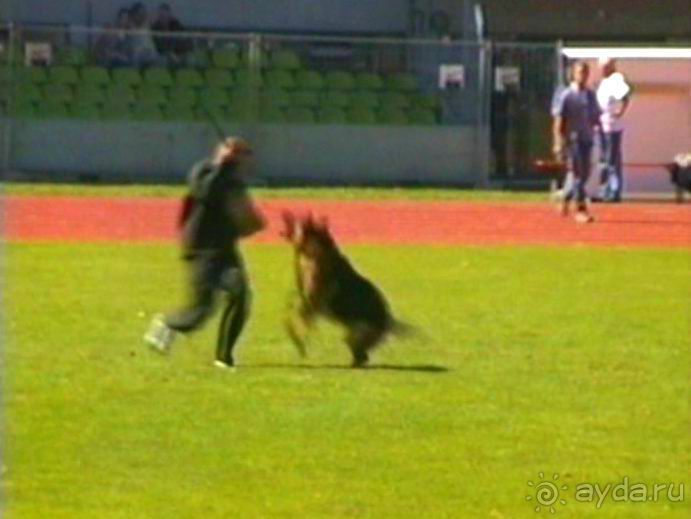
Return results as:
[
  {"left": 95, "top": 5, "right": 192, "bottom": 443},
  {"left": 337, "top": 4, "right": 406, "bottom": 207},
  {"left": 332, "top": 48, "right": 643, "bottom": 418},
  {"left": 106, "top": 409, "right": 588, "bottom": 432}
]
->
[{"left": 165, "top": 254, "right": 250, "bottom": 365}]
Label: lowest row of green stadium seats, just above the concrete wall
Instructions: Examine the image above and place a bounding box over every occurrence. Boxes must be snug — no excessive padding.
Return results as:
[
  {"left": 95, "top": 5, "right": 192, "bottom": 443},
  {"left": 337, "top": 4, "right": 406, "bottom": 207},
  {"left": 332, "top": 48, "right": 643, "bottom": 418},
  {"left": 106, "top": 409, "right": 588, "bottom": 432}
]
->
[{"left": 5, "top": 100, "right": 437, "bottom": 125}]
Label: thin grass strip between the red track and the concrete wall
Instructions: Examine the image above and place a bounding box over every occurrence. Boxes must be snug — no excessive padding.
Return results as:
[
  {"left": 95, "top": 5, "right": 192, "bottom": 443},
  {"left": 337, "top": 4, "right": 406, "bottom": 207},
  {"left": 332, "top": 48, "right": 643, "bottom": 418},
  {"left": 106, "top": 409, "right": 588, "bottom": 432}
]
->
[{"left": 3, "top": 183, "right": 546, "bottom": 202}]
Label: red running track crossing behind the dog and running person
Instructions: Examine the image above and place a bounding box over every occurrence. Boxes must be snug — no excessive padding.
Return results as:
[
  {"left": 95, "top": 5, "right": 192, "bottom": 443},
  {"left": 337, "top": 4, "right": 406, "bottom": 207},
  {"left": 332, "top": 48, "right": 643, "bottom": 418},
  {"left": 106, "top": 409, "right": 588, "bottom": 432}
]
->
[{"left": 3, "top": 196, "right": 691, "bottom": 248}]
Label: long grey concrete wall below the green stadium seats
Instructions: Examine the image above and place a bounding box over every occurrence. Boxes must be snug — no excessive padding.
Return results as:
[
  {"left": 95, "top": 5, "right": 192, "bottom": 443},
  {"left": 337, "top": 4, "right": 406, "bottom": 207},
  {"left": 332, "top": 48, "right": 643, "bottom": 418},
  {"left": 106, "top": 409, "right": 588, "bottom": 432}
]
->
[{"left": 6, "top": 121, "right": 482, "bottom": 185}]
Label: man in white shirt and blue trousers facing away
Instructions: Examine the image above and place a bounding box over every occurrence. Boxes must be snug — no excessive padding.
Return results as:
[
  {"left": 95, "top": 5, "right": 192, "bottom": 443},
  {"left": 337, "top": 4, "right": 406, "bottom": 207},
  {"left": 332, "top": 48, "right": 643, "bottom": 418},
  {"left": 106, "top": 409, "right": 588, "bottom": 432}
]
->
[{"left": 597, "top": 58, "right": 631, "bottom": 202}]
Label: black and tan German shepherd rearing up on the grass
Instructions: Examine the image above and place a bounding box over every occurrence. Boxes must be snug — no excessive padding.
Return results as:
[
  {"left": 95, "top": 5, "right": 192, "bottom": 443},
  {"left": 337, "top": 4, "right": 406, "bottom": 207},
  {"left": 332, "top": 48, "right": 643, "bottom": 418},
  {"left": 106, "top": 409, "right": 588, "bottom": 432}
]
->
[{"left": 282, "top": 213, "right": 409, "bottom": 367}]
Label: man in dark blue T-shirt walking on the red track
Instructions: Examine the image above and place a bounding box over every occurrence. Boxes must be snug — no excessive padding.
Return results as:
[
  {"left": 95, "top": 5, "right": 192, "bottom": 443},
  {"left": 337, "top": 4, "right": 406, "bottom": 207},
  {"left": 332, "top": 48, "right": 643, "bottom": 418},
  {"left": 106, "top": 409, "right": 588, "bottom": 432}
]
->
[{"left": 552, "top": 61, "right": 600, "bottom": 223}]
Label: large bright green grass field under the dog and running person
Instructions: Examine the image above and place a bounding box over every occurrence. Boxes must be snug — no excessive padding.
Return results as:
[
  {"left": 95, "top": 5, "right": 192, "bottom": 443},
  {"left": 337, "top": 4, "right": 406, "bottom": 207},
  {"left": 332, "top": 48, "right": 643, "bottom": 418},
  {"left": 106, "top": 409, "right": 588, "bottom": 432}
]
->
[{"left": 4, "top": 244, "right": 691, "bottom": 519}]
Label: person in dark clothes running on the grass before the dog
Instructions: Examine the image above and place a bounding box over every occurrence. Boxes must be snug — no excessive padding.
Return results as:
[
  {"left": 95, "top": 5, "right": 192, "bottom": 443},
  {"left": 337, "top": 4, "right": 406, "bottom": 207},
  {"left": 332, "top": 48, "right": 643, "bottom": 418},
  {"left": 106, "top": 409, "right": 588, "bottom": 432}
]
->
[{"left": 144, "top": 138, "right": 264, "bottom": 368}]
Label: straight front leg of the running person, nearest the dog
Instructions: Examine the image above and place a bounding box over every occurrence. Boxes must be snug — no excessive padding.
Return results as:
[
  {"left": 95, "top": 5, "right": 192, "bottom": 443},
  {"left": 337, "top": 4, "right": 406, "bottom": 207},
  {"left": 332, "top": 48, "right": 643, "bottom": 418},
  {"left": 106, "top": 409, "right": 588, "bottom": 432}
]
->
[{"left": 216, "top": 266, "right": 251, "bottom": 366}]
